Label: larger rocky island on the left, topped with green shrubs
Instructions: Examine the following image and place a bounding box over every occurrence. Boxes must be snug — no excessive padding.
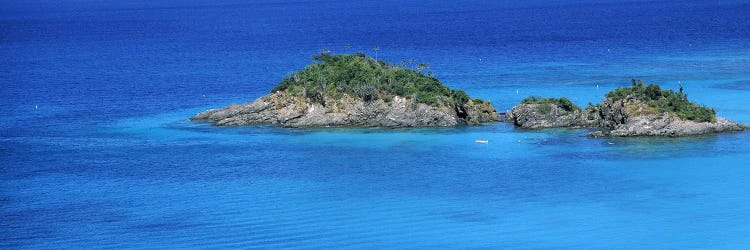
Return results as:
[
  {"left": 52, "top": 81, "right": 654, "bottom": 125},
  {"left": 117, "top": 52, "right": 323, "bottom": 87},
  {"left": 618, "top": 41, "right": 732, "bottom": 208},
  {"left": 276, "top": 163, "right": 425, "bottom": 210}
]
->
[{"left": 190, "top": 53, "right": 500, "bottom": 128}]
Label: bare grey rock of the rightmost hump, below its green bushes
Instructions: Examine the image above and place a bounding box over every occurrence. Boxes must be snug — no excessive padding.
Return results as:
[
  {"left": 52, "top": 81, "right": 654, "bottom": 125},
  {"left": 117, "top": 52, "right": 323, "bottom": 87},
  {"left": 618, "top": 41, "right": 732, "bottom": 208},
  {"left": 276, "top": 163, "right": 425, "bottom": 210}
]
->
[{"left": 591, "top": 96, "right": 748, "bottom": 136}]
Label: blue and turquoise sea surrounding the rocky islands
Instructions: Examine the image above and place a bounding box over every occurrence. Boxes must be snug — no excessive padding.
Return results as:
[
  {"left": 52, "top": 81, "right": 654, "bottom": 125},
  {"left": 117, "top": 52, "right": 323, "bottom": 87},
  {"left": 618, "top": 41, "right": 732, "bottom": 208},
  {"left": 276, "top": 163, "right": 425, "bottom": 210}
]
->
[{"left": 0, "top": 0, "right": 750, "bottom": 249}]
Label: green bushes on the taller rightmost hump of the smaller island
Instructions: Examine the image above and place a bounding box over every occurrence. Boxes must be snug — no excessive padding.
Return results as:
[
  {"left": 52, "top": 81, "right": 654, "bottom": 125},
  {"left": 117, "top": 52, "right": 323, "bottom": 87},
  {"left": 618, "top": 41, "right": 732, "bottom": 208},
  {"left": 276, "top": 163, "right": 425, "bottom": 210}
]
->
[{"left": 606, "top": 79, "right": 716, "bottom": 122}]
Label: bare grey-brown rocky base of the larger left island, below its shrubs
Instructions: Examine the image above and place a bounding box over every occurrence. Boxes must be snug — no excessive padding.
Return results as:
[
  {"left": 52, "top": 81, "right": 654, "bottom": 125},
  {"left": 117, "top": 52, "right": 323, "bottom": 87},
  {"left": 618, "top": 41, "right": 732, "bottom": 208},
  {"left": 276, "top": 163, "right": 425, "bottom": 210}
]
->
[{"left": 191, "top": 91, "right": 500, "bottom": 128}]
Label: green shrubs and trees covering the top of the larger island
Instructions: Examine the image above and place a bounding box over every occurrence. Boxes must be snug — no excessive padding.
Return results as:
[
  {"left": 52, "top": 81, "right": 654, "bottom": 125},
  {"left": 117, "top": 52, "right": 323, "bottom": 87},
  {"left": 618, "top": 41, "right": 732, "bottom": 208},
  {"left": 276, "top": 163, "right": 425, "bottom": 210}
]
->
[{"left": 271, "top": 52, "right": 484, "bottom": 106}]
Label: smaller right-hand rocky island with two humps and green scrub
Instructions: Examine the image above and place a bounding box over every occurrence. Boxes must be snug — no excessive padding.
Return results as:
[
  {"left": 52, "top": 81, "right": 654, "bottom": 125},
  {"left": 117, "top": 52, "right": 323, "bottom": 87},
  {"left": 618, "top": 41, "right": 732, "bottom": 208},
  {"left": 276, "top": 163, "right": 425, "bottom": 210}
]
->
[{"left": 506, "top": 79, "right": 748, "bottom": 136}]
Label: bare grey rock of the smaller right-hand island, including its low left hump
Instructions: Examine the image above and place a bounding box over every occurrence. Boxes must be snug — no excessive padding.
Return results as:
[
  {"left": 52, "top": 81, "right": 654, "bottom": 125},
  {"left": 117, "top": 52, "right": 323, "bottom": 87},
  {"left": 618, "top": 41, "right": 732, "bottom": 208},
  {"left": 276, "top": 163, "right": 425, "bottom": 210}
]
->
[{"left": 506, "top": 96, "right": 748, "bottom": 136}]
